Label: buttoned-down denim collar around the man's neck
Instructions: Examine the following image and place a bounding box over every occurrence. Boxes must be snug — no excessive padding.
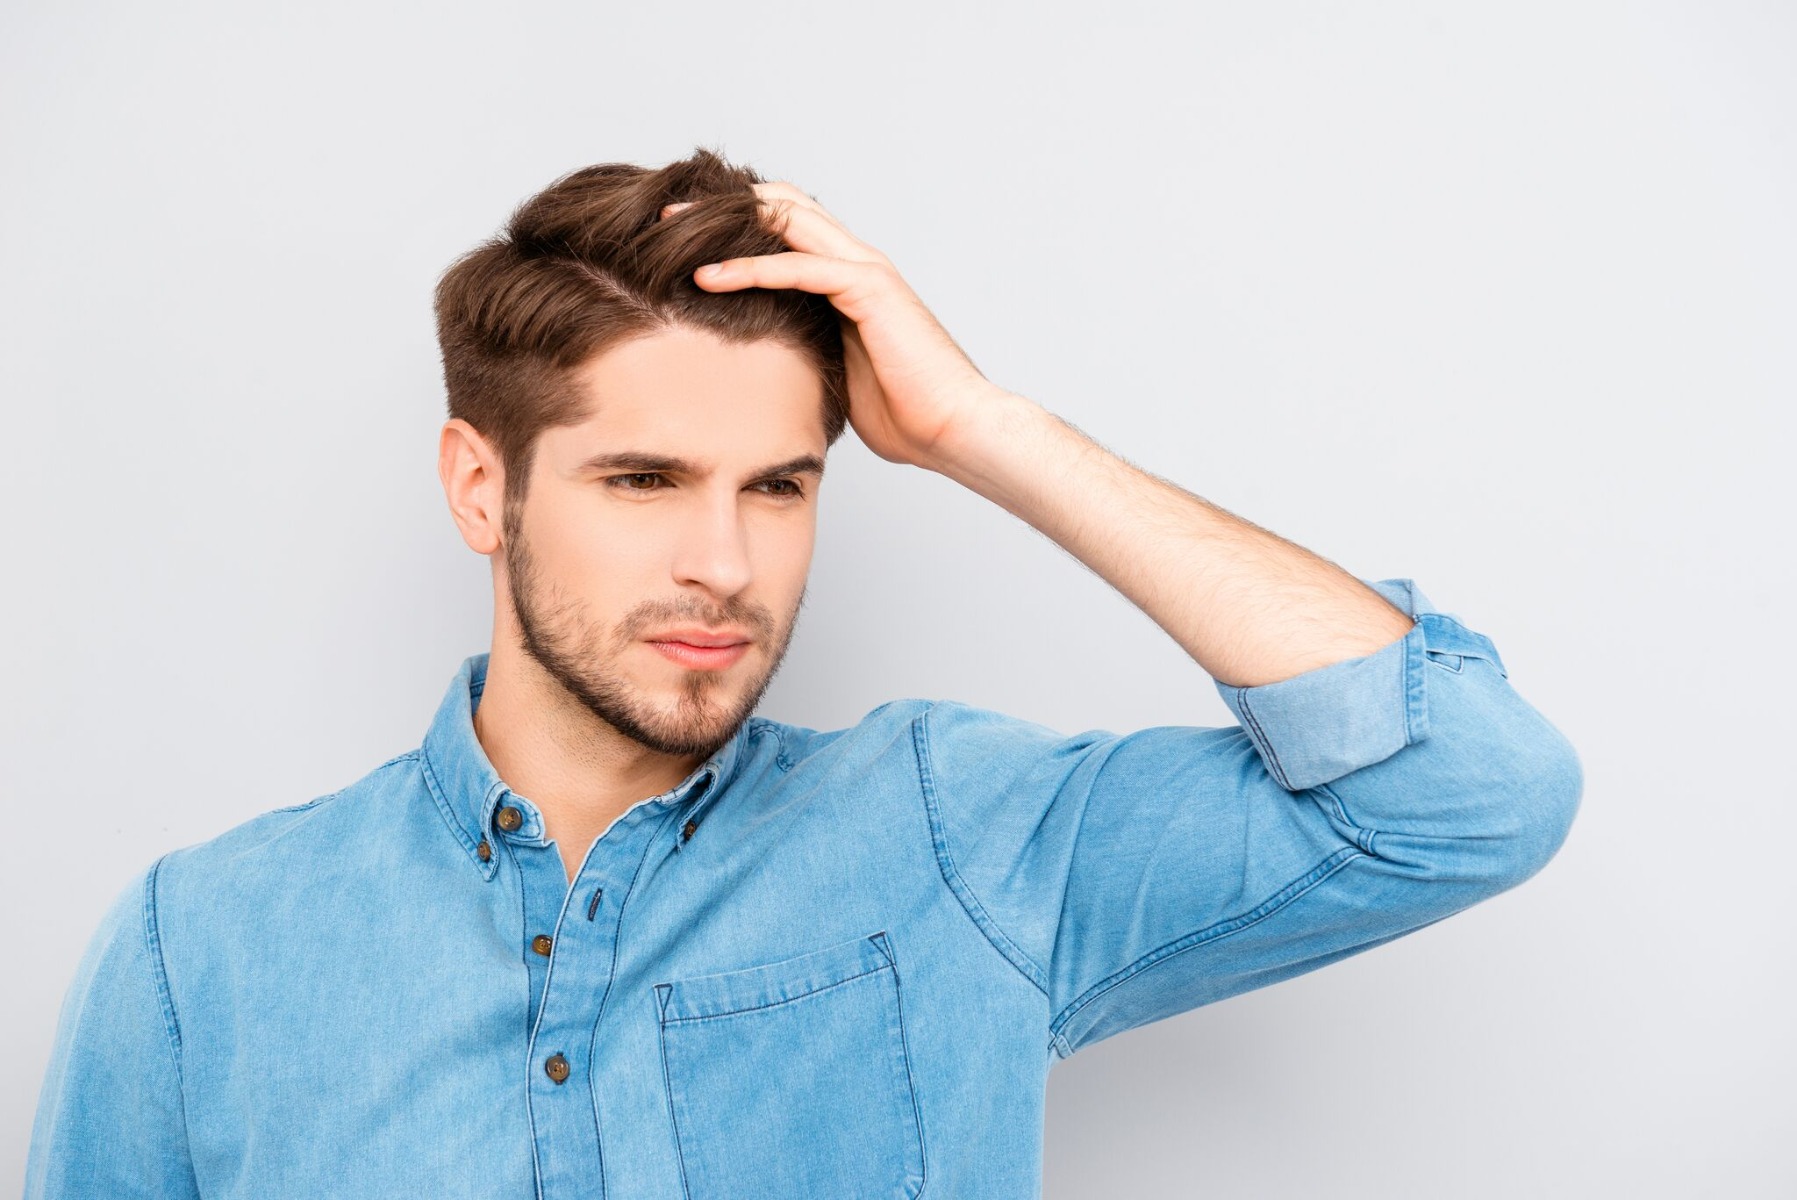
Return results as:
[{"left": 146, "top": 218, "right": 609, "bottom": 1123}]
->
[{"left": 422, "top": 652, "right": 755, "bottom": 878}]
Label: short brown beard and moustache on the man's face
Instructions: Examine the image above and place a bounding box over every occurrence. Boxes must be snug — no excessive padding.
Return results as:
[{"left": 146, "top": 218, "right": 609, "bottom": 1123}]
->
[{"left": 503, "top": 488, "right": 805, "bottom": 756}]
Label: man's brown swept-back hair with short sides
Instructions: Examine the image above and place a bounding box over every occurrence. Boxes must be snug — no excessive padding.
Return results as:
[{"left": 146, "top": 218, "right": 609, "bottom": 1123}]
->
[{"left": 435, "top": 147, "right": 848, "bottom": 505}]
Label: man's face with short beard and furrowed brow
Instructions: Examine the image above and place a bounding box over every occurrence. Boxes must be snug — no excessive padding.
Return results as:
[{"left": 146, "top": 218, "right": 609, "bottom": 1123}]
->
[{"left": 503, "top": 329, "right": 827, "bottom": 756}]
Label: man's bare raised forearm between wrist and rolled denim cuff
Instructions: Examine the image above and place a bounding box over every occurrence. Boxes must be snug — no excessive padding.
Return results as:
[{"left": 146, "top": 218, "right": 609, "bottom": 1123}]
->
[{"left": 929, "top": 388, "right": 1412, "bottom": 688}]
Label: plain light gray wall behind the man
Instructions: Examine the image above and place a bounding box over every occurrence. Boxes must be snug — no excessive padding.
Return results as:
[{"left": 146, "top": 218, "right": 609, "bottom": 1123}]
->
[{"left": 0, "top": 0, "right": 1797, "bottom": 1200}]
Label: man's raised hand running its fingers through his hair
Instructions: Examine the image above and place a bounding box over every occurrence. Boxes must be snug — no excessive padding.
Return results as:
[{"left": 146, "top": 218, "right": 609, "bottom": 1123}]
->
[{"left": 663, "top": 181, "right": 1008, "bottom": 469}]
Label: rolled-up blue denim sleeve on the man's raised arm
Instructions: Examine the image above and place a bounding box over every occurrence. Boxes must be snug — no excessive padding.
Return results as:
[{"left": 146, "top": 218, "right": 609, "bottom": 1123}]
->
[{"left": 918, "top": 578, "right": 1583, "bottom": 1056}]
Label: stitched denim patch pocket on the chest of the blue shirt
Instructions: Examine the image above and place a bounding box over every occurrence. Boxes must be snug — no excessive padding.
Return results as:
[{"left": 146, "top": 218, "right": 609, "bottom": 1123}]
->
[{"left": 656, "top": 932, "right": 924, "bottom": 1200}]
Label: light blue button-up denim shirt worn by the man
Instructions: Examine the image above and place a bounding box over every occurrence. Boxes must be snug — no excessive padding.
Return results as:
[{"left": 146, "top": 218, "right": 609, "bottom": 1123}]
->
[{"left": 25, "top": 578, "right": 1583, "bottom": 1200}]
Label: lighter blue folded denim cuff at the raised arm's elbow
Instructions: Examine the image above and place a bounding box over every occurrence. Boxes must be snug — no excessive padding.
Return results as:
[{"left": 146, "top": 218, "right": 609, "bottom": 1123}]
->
[{"left": 1213, "top": 578, "right": 1508, "bottom": 792}]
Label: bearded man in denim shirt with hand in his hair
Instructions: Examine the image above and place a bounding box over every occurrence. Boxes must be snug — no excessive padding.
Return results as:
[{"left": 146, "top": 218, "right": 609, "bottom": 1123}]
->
[{"left": 27, "top": 151, "right": 1583, "bottom": 1200}]
